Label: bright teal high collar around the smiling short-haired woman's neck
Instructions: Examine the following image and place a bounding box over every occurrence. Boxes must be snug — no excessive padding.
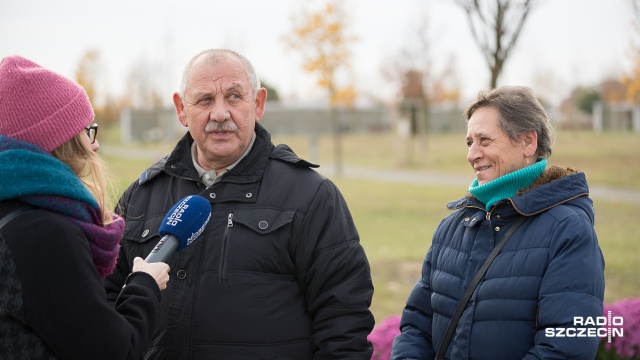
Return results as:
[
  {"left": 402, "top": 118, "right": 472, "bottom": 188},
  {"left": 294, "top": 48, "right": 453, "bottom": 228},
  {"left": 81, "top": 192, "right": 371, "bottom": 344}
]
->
[{"left": 469, "top": 159, "right": 547, "bottom": 212}]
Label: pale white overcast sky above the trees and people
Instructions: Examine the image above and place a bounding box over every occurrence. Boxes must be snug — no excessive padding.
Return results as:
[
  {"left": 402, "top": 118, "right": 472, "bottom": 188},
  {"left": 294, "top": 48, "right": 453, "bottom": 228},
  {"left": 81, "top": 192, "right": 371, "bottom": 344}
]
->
[{"left": 0, "top": 0, "right": 640, "bottom": 106}]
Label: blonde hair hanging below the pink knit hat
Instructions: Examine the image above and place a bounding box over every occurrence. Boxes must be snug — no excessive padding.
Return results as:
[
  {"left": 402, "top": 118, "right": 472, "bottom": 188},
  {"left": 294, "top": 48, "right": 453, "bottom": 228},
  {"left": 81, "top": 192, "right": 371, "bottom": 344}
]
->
[{"left": 51, "top": 131, "right": 113, "bottom": 225}]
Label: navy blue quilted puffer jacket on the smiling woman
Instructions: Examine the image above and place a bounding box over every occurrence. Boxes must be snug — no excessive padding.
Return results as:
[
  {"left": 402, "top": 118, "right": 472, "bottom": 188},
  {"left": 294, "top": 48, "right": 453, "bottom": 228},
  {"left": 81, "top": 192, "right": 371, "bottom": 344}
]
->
[{"left": 392, "top": 166, "right": 604, "bottom": 359}]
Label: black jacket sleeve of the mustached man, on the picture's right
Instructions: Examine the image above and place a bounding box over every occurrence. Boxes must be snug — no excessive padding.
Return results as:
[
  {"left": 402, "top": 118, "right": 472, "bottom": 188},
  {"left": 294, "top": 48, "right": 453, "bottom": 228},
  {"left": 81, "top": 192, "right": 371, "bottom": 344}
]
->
[{"left": 297, "top": 180, "right": 374, "bottom": 360}]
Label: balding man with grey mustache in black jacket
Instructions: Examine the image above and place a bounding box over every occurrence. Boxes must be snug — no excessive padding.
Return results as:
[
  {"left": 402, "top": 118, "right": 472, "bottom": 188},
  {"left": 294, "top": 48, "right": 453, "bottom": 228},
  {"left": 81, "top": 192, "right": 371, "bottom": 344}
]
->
[{"left": 105, "top": 49, "right": 374, "bottom": 360}]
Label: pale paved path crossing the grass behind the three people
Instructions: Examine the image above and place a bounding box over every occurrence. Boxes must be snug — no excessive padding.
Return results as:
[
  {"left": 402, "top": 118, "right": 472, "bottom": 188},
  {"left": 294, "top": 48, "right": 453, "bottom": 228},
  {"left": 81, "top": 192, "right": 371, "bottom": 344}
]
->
[{"left": 100, "top": 145, "right": 640, "bottom": 204}]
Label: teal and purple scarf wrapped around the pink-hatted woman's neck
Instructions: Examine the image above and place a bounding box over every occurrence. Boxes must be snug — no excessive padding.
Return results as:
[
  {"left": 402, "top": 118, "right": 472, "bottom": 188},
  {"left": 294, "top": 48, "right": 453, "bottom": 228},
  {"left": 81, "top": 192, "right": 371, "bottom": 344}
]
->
[{"left": 0, "top": 135, "right": 124, "bottom": 278}]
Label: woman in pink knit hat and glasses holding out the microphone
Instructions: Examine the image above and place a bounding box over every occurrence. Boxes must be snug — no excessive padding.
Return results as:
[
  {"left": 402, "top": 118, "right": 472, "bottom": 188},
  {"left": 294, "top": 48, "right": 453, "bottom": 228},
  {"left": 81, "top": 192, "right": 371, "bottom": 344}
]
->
[{"left": 0, "top": 56, "right": 169, "bottom": 360}]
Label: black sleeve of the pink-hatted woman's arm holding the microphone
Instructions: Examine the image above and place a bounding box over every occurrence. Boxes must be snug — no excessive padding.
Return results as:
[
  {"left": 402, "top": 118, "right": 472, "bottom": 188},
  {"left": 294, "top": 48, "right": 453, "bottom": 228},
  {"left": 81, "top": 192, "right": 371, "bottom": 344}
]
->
[{"left": 8, "top": 210, "right": 160, "bottom": 360}]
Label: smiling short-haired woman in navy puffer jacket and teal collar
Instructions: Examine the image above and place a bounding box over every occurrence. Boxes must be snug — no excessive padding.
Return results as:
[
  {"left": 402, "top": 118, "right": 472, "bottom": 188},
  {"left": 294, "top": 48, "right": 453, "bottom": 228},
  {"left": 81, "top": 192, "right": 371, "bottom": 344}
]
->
[{"left": 391, "top": 87, "right": 604, "bottom": 359}]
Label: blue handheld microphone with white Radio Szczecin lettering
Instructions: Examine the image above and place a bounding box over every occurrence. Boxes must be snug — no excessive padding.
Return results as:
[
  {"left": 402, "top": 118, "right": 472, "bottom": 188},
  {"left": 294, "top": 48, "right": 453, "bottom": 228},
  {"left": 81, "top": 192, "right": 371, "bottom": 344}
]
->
[{"left": 144, "top": 195, "right": 211, "bottom": 263}]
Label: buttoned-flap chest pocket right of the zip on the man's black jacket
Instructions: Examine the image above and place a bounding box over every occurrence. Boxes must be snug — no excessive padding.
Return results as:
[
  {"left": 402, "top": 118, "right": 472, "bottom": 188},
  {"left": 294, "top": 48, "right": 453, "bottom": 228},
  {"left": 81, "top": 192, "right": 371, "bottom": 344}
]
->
[{"left": 223, "top": 208, "right": 295, "bottom": 274}]
